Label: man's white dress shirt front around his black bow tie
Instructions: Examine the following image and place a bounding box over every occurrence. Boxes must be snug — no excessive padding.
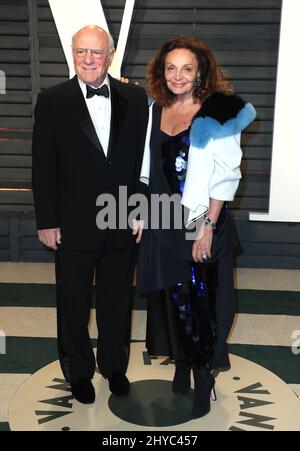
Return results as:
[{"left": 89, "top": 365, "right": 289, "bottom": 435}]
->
[{"left": 77, "top": 76, "right": 111, "bottom": 156}]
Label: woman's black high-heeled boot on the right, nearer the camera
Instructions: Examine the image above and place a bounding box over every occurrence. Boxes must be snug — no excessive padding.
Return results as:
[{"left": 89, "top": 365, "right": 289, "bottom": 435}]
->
[{"left": 192, "top": 364, "right": 215, "bottom": 418}]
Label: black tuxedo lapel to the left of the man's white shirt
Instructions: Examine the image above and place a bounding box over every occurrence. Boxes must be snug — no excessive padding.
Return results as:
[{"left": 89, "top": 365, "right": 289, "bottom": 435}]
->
[{"left": 68, "top": 76, "right": 105, "bottom": 157}]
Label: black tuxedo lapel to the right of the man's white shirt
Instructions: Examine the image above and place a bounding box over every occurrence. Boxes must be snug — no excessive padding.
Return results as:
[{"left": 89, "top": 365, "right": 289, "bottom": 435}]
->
[{"left": 107, "top": 77, "right": 127, "bottom": 158}]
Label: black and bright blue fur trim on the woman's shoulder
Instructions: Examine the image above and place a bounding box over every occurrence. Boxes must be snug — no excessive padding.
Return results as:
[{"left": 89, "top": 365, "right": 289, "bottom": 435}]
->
[{"left": 190, "top": 93, "right": 256, "bottom": 148}]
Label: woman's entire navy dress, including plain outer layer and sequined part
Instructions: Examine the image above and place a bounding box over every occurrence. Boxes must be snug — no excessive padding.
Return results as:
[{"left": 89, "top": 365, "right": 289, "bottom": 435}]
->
[{"left": 137, "top": 105, "right": 235, "bottom": 368}]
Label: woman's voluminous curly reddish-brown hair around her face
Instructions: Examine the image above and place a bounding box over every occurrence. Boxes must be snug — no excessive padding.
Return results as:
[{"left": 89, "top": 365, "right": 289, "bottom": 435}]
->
[{"left": 147, "top": 36, "right": 233, "bottom": 106}]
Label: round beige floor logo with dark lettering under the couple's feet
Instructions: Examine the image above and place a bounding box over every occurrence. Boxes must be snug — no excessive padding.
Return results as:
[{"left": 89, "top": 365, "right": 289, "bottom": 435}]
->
[{"left": 9, "top": 343, "right": 300, "bottom": 431}]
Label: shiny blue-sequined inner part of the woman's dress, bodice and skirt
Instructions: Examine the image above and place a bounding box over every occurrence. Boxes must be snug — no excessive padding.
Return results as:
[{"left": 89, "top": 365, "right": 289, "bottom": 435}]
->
[{"left": 155, "top": 129, "right": 215, "bottom": 365}]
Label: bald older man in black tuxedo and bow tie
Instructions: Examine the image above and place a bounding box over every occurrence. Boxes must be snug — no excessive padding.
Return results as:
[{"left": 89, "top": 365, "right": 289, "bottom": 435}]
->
[{"left": 32, "top": 25, "right": 148, "bottom": 403}]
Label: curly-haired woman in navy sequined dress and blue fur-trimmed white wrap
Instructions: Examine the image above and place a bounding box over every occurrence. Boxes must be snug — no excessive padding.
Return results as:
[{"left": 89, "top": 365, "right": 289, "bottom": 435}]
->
[{"left": 137, "top": 37, "right": 255, "bottom": 418}]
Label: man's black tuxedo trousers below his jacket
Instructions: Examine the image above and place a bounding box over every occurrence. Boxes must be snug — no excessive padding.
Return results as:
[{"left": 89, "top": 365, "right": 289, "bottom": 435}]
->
[{"left": 56, "top": 241, "right": 136, "bottom": 382}]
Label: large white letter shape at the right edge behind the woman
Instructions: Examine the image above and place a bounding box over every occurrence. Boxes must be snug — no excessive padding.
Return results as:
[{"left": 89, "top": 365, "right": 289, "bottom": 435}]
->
[{"left": 250, "top": 0, "right": 300, "bottom": 222}]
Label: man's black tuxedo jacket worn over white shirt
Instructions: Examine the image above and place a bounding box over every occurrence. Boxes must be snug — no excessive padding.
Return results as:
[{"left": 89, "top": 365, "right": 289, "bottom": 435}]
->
[{"left": 32, "top": 76, "right": 148, "bottom": 251}]
